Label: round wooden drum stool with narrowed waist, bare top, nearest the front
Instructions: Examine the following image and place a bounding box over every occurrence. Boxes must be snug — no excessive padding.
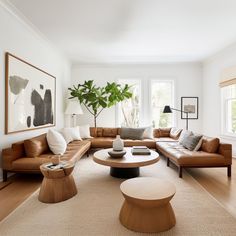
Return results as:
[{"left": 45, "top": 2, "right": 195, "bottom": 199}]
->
[{"left": 120, "top": 177, "right": 176, "bottom": 233}]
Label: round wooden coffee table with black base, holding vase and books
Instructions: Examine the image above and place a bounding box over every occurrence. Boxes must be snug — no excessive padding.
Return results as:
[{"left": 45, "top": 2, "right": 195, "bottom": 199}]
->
[{"left": 93, "top": 148, "right": 160, "bottom": 178}]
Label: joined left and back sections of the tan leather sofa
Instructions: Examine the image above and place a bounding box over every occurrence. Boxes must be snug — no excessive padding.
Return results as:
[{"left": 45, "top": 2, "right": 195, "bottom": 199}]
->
[{"left": 2, "top": 128, "right": 180, "bottom": 181}]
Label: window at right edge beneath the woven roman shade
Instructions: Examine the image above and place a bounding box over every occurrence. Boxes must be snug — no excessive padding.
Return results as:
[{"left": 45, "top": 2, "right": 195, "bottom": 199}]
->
[{"left": 221, "top": 84, "right": 236, "bottom": 136}]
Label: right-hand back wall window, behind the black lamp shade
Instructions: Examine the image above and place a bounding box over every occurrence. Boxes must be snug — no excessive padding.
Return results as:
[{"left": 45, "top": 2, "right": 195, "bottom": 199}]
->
[{"left": 151, "top": 80, "right": 174, "bottom": 128}]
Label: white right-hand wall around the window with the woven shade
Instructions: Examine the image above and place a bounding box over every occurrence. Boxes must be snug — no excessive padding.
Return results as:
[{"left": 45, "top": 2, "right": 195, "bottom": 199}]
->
[{"left": 203, "top": 44, "right": 236, "bottom": 156}]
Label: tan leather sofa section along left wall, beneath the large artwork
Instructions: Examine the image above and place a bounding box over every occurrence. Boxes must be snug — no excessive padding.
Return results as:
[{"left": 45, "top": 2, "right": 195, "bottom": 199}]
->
[{"left": 2, "top": 134, "right": 91, "bottom": 181}]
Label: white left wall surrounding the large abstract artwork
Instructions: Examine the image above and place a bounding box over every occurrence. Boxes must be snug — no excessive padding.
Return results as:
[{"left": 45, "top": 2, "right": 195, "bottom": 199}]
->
[{"left": 0, "top": 3, "right": 71, "bottom": 179}]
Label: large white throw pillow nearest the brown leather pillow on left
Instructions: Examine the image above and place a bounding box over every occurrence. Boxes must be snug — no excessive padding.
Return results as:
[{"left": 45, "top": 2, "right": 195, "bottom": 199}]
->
[{"left": 47, "top": 129, "right": 67, "bottom": 155}]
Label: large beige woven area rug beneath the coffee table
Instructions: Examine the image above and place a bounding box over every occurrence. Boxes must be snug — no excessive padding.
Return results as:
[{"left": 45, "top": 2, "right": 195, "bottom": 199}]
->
[{"left": 0, "top": 157, "right": 236, "bottom": 236}]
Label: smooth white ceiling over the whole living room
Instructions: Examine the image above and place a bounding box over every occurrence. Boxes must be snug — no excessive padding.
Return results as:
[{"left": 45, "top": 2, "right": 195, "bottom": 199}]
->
[{"left": 6, "top": 0, "right": 236, "bottom": 63}]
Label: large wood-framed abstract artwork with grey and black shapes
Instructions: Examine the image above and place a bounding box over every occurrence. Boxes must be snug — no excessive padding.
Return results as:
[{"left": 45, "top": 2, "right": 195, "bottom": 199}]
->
[{"left": 5, "top": 53, "right": 56, "bottom": 134}]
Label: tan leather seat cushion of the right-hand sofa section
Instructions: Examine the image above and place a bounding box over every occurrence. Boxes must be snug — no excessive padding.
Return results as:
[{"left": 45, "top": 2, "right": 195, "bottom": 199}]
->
[{"left": 156, "top": 142, "right": 226, "bottom": 166}]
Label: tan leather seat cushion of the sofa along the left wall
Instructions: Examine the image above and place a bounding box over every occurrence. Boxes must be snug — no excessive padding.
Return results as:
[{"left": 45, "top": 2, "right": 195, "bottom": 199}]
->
[{"left": 12, "top": 140, "right": 91, "bottom": 171}]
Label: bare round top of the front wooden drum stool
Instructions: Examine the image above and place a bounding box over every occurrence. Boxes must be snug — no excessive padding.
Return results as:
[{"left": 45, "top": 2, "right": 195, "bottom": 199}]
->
[{"left": 120, "top": 177, "right": 176, "bottom": 200}]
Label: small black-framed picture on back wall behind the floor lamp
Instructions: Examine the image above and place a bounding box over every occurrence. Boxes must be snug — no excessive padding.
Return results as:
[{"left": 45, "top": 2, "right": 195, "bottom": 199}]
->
[{"left": 181, "top": 97, "right": 198, "bottom": 119}]
